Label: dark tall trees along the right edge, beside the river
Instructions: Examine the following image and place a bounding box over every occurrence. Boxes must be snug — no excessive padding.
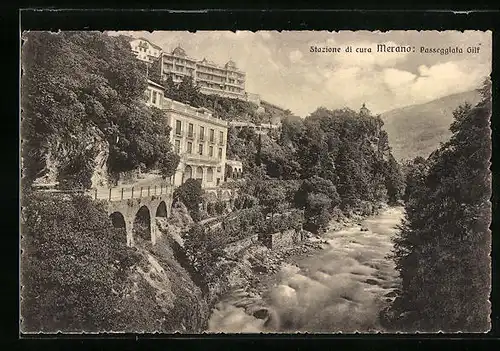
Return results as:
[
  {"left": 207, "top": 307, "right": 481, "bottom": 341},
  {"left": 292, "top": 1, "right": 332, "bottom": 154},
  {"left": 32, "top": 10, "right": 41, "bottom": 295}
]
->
[{"left": 386, "top": 82, "right": 491, "bottom": 332}]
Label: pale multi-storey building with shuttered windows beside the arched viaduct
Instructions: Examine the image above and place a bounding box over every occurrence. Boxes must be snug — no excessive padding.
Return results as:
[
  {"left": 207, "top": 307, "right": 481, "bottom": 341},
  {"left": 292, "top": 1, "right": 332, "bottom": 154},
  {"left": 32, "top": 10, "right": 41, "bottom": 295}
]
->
[{"left": 147, "top": 81, "right": 242, "bottom": 188}]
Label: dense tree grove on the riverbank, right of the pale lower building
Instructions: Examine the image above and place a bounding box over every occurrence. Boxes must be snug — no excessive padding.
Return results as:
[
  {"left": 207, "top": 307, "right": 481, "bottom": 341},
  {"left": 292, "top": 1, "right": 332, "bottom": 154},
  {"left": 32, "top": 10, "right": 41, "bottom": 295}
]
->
[{"left": 228, "top": 108, "right": 404, "bottom": 232}]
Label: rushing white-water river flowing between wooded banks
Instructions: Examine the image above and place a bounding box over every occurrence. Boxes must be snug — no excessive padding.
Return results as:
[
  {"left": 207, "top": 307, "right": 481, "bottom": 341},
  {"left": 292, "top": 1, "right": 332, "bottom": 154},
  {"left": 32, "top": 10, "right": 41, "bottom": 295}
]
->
[{"left": 208, "top": 207, "right": 403, "bottom": 333}]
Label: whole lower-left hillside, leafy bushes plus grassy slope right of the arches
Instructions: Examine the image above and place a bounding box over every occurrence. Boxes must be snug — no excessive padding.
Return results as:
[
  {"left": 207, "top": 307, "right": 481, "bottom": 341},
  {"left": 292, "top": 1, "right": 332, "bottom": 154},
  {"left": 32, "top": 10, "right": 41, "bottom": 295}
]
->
[{"left": 21, "top": 192, "right": 207, "bottom": 333}]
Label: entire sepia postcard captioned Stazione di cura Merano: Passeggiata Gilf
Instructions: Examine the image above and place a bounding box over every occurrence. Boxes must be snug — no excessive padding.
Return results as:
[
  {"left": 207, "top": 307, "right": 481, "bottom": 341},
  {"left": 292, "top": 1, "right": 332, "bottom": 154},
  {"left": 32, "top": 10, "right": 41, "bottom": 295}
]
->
[{"left": 20, "top": 31, "right": 492, "bottom": 334}]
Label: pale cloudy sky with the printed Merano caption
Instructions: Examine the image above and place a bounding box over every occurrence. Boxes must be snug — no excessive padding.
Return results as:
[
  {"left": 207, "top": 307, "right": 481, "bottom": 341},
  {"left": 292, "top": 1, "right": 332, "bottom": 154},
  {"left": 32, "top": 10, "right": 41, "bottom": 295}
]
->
[{"left": 110, "top": 31, "right": 492, "bottom": 117}]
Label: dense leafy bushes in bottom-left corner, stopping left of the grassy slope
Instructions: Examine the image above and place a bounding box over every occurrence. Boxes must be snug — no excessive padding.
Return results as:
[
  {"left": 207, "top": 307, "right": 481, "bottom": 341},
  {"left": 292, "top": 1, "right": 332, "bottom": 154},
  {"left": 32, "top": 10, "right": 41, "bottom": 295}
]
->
[{"left": 21, "top": 194, "right": 140, "bottom": 332}]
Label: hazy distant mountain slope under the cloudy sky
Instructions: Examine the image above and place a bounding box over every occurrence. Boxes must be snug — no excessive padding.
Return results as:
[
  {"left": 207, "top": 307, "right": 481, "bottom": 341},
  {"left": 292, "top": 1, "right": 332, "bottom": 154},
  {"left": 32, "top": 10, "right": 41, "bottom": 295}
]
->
[{"left": 381, "top": 90, "right": 481, "bottom": 160}]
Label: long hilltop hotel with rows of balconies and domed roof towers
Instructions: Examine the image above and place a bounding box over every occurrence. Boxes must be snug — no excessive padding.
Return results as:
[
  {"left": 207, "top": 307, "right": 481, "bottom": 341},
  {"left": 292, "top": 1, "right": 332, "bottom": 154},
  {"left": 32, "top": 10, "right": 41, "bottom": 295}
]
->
[{"left": 161, "top": 46, "right": 247, "bottom": 101}]
